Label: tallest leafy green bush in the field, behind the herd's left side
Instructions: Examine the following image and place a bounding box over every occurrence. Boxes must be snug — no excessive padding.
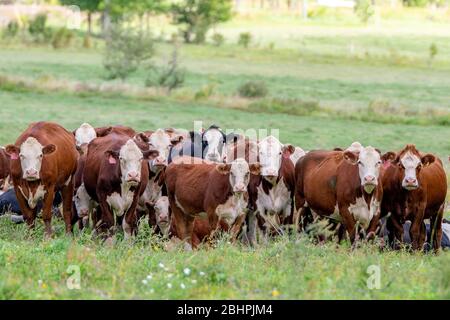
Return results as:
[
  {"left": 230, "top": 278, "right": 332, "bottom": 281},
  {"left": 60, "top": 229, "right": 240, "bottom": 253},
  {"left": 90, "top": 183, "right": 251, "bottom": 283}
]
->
[{"left": 103, "top": 25, "right": 154, "bottom": 81}]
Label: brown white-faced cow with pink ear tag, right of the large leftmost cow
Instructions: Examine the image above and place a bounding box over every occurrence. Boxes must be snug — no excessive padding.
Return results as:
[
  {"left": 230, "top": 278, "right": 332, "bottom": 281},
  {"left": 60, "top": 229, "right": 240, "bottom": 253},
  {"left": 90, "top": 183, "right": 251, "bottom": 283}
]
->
[{"left": 83, "top": 132, "right": 157, "bottom": 237}]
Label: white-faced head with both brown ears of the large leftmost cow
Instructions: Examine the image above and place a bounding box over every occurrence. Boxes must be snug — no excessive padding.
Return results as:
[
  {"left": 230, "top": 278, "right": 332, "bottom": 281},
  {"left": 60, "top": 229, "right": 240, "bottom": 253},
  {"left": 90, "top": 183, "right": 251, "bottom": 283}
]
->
[{"left": 6, "top": 137, "right": 56, "bottom": 181}]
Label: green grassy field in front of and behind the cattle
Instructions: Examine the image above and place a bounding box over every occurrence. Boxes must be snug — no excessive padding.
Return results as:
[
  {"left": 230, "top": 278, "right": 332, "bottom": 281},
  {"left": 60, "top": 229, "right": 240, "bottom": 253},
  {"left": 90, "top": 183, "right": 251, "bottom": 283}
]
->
[{"left": 0, "top": 13, "right": 450, "bottom": 299}]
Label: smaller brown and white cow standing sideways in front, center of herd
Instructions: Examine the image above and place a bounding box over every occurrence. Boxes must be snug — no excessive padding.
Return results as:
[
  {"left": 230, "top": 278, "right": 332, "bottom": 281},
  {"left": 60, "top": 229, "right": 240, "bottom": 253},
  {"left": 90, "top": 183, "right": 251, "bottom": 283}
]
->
[{"left": 166, "top": 157, "right": 259, "bottom": 247}]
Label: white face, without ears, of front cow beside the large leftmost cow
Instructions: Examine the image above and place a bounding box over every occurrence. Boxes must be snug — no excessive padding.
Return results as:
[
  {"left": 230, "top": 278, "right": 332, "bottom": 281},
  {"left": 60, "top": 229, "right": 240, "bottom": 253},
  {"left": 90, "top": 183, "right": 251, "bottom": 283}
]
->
[{"left": 119, "top": 139, "right": 144, "bottom": 185}]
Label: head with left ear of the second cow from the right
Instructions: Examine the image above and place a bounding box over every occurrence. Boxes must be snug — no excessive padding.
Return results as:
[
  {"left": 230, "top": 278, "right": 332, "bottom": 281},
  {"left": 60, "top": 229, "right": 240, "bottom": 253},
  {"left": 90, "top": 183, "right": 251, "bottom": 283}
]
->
[{"left": 344, "top": 146, "right": 381, "bottom": 193}]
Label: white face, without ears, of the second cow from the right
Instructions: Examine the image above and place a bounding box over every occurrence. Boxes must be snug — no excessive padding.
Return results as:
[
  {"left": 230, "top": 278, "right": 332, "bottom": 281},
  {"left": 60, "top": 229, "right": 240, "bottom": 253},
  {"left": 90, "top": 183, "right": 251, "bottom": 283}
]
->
[{"left": 358, "top": 146, "right": 381, "bottom": 192}]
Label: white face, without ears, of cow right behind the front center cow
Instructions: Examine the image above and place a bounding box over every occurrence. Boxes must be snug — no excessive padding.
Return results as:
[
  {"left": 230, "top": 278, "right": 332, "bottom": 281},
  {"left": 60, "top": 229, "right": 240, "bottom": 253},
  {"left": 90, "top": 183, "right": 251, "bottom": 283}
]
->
[{"left": 258, "top": 136, "right": 283, "bottom": 176}]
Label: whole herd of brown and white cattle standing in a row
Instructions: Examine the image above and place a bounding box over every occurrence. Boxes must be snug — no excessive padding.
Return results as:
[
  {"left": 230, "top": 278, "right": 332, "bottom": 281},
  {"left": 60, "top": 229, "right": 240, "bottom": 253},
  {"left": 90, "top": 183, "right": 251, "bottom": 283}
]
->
[{"left": 0, "top": 122, "right": 447, "bottom": 250}]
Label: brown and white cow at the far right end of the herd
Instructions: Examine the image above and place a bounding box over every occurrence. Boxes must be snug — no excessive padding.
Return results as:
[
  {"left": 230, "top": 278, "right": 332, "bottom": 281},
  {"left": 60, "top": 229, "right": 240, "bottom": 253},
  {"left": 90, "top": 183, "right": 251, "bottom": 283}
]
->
[{"left": 381, "top": 144, "right": 447, "bottom": 250}]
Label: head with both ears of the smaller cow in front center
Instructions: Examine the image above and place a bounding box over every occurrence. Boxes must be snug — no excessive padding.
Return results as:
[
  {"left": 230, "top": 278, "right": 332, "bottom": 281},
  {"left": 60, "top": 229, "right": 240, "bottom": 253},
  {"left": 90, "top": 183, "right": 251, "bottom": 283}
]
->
[{"left": 216, "top": 158, "right": 260, "bottom": 194}]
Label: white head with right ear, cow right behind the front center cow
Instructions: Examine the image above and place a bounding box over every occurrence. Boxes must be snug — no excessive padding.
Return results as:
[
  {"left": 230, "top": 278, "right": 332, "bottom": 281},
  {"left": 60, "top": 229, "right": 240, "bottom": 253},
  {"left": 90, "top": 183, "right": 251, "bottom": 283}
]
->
[{"left": 258, "top": 136, "right": 295, "bottom": 182}]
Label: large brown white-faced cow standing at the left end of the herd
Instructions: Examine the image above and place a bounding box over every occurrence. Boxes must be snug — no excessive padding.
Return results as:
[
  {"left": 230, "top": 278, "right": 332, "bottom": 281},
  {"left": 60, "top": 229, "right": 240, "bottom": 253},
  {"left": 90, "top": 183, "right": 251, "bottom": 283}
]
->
[{"left": 6, "top": 122, "right": 78, "bottom": 236}]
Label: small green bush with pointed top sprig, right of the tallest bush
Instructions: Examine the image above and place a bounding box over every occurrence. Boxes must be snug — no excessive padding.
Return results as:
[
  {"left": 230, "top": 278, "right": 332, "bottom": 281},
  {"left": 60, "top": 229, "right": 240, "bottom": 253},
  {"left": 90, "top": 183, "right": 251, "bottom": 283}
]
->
[{"left": 145, "top": 45, "right": 185, "bottom": 93}]
